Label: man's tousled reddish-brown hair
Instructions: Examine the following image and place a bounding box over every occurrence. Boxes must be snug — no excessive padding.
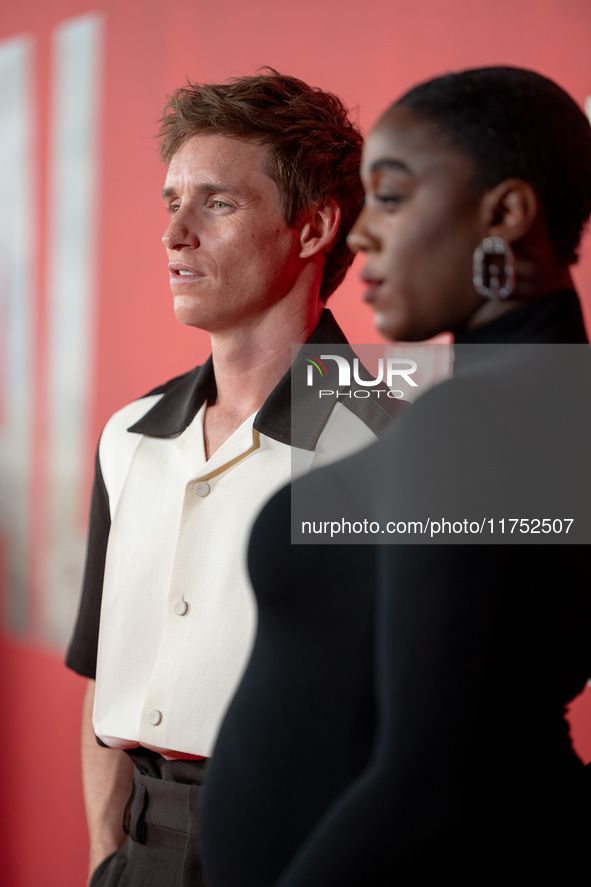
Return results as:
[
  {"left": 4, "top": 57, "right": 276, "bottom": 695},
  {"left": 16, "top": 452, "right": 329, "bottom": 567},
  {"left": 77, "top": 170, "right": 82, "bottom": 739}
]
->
[{"left": 159, "top": 68, "right": 363, "bottom": 300}]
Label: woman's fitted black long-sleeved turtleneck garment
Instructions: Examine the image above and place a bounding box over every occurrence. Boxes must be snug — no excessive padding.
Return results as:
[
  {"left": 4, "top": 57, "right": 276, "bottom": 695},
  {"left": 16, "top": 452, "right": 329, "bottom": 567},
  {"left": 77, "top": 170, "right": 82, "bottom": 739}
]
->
[{"left": 201, "top": 293, "right": 591, "bottom": 887}]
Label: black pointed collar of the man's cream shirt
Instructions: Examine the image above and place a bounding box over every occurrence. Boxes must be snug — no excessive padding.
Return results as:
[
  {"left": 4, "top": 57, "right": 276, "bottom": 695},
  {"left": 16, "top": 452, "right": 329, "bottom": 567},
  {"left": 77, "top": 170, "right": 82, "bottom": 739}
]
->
[{"left": 127, "top": 309, "right": 354, "bottom": 450}]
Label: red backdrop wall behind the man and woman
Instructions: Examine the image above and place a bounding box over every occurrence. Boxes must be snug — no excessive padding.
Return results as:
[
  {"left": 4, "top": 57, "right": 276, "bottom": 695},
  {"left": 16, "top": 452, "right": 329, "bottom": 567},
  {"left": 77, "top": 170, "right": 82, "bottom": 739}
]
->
[{"left": 0, "top": 0, "right": 591, "bottom": 887}]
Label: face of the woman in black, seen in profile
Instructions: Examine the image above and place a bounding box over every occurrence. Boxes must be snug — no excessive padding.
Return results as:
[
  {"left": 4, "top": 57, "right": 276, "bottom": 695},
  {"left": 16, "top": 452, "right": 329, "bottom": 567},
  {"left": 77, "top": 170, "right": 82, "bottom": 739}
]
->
[{"left": 348, "top": 107, "right": 487, "bottom": 341}]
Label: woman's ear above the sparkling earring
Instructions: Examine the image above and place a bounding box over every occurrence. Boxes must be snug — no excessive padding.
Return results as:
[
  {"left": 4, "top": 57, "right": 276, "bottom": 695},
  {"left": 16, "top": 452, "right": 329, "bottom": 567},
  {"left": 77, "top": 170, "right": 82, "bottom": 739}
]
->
[{"left": 483, "top": 179, "right": 539, "bottom": 243}]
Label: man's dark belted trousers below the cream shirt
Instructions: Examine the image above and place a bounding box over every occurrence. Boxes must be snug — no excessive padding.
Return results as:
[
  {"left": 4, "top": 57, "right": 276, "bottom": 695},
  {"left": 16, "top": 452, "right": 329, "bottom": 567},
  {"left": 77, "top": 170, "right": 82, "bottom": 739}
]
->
[{"left": 90, "top": 753, "right": 207, "bottom": 887}]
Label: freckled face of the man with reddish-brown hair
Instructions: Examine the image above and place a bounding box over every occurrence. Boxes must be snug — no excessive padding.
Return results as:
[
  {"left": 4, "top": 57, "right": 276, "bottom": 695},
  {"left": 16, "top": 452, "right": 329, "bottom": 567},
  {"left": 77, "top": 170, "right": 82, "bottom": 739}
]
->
[{"left": 162, "top": 134, "right": 301, "bottom": 332}]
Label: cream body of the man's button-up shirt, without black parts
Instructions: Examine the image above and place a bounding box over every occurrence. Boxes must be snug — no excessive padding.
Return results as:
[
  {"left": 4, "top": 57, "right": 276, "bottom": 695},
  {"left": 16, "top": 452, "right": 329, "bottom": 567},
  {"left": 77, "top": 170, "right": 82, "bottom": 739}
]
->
[{"left": 94, "top": 397, "right": 375, "bottom": 756}]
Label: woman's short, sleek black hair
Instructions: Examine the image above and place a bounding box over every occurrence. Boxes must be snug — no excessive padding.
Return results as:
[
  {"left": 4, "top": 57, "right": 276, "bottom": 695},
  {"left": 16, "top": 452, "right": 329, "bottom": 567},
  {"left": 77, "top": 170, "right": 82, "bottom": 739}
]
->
[{"left": 394, "top": 67, "right": 591, "bottom": 264}]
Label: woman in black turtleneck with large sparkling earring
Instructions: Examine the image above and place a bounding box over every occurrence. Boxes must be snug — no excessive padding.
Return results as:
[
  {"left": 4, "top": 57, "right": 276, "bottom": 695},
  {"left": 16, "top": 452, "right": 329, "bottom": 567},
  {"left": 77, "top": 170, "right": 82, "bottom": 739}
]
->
[{"left": 203, "top": 67, "right": 591, "bottom": 887}]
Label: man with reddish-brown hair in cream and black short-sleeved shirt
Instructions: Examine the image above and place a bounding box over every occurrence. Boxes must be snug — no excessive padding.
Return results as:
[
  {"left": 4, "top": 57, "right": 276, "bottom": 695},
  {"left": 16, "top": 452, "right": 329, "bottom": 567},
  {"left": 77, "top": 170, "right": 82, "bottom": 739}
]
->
[{"left": 67, "top": 70, "right": 396, "bottom": 887}]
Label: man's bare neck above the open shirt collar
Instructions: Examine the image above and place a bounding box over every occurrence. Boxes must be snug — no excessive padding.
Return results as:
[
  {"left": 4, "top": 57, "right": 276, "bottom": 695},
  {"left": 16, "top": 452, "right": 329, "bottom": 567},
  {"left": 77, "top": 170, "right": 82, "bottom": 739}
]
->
[{"left": 204, "top": 300, "right": 323, "bottom": 458}]
